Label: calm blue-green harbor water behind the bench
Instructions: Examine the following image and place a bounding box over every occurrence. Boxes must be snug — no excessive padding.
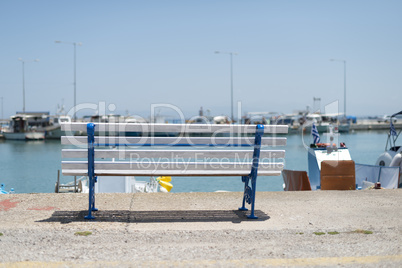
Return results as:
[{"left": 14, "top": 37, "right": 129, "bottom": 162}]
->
[{"left": 0, "top": 130, "right": 387, "bottom": 193}]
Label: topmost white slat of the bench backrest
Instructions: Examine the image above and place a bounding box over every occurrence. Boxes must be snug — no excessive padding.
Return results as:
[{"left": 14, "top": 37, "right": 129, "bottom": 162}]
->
[{"left": 61, "top": 122, "right": 288, "bottom": 134}]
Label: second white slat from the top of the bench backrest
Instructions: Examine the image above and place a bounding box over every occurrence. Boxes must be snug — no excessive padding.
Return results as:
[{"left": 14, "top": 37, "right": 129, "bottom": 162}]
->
[{"left": 61, "top": 136, "right": 286, "bottom": 146}]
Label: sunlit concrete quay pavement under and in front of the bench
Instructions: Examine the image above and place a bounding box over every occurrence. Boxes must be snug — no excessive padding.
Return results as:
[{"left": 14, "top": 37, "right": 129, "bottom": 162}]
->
[{"left": 0, "top": 189, "right": 402, "bottom": 267}]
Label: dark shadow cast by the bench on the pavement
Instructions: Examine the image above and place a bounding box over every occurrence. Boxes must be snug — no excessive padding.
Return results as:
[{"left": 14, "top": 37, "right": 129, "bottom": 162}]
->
[{"left": 37, "top": 210, "right": 270, "bottom": 224}]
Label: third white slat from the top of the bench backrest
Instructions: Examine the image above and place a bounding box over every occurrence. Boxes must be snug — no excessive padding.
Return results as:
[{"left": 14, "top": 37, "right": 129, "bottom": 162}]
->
[{"left": 61, "top": 149, "right": 285, "bottom": 160}]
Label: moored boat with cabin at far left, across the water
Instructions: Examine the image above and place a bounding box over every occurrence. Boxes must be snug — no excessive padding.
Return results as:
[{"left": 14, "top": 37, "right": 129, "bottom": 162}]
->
[{"left": 3, "top": 113, "right": 45, "bottom": 140}]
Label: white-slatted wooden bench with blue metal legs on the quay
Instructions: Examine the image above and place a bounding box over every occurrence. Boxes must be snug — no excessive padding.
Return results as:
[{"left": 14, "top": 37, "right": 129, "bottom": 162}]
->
[{"left": 61, "top": 123, "right": 288, "bottom": 219}]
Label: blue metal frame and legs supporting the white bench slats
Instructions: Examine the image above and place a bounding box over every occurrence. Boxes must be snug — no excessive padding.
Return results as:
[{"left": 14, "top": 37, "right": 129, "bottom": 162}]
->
[{"left": 85, "top": 123, "right": 264, "bottom": 219}]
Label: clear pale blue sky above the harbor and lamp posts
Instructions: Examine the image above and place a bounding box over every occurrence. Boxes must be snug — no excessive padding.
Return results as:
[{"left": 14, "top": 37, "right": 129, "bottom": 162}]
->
[{"left": 0, "top": 0, "right": 402, "bottom": 117}]
